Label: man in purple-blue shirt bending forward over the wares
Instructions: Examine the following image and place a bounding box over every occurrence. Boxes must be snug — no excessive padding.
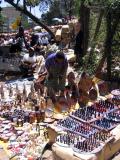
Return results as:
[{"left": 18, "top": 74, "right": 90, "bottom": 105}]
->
[{"left": 45, "top": 51, "right": 68, "bottom": 102}]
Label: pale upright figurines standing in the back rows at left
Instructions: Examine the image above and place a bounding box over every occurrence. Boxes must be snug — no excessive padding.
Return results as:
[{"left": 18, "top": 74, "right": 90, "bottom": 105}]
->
[{"left": 0, "top": 83, "right": 53, "bottom": 110}]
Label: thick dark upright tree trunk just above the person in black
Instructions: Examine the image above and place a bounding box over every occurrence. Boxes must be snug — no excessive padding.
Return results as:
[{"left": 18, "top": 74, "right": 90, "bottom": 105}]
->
[{"left": 80, "top": 1, "right": 90, "bottom": 55}]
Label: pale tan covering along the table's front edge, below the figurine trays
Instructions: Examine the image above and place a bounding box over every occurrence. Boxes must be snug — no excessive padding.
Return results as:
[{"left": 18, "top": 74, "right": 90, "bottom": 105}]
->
[{"left": 52, "top": 125, "right": 120, "bottom": 160}]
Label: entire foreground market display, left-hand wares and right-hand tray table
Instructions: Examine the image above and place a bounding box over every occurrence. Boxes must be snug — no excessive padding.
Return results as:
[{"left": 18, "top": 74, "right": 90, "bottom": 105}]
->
[{"left": 0, "top": 75, "right": 120, "bottom": 160}]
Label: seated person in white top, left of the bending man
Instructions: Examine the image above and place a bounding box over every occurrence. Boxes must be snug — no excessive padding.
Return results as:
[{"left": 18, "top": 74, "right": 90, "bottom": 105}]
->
[{"left": 20, "top": 47, "right": 37, "bottom": 76}]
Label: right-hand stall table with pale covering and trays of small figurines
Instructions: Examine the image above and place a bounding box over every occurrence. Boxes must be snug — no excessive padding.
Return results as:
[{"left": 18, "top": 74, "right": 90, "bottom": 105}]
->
[{"left": 52, "top": 92, "right": 120, "bottom": 160}]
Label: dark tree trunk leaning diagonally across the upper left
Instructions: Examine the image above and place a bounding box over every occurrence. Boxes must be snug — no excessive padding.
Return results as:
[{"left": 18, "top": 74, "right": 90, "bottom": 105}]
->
[{"left": 5, "top": 0, "right": 55, "bottom": 39}]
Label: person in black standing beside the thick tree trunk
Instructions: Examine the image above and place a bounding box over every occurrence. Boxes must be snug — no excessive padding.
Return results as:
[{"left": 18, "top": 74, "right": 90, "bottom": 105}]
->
[{"left": 74, "top": 22, "right": 84, "bottom": 66}]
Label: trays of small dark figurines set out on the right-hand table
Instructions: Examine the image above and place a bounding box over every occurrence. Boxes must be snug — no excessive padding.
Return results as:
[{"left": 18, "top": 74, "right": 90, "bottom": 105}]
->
[{"left": 56, "top": 97, "right": 120, "bottom": 154}]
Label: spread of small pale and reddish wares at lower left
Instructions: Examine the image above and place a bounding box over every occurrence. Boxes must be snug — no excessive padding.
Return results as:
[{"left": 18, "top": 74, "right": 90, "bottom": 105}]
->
[{"left": 0, "top": 119, "right": 48, "bottom": 160}]
